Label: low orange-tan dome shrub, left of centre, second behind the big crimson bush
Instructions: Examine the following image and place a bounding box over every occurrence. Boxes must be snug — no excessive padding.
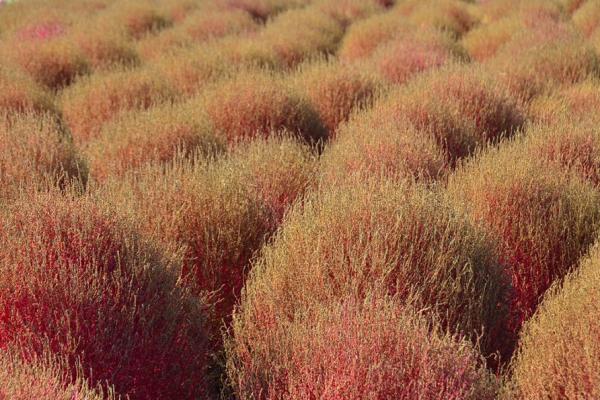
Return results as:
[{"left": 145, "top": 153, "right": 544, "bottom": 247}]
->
[{"left": 84, "top": 103, "right": 224, "bottom": 181}]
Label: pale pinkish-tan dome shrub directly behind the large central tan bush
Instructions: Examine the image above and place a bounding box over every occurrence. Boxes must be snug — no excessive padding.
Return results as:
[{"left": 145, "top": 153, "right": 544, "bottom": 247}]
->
[{"left": 320, "top": 110, "right": 449, "bottom": 184}]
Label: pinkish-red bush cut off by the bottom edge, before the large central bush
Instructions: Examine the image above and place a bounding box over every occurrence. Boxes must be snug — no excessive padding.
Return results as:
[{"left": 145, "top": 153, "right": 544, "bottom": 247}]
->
[{"left": 228, "top": 300, "right": 494, "bottom": 400}]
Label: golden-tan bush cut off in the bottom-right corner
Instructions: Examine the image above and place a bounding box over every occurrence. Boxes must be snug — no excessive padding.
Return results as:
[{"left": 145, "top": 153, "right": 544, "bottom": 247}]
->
[{"left": 512, "top": 242, "right": 600, "bottom": 400}]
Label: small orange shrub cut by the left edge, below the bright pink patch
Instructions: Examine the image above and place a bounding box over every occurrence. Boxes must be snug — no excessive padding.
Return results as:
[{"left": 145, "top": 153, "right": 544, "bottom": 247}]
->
[{"left": 0, "top": 66, "right": 56, "bottom": 114}]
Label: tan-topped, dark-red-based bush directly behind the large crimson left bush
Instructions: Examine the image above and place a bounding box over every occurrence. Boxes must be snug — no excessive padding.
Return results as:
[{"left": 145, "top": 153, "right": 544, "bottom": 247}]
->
[{"left": 100, "top": 160, "right": 275, "bottom": 321}]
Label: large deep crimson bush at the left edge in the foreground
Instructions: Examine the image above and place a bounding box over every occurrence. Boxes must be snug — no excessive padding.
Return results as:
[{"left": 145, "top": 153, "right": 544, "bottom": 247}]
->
[{"left": 0, "top": 193, "right": 210, "bottom": 400}]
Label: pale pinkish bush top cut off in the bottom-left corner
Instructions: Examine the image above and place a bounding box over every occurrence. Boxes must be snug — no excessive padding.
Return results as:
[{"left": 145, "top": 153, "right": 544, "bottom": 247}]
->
[{"left": 0, "top": 353, "right": 116, "bottom": 400}]
